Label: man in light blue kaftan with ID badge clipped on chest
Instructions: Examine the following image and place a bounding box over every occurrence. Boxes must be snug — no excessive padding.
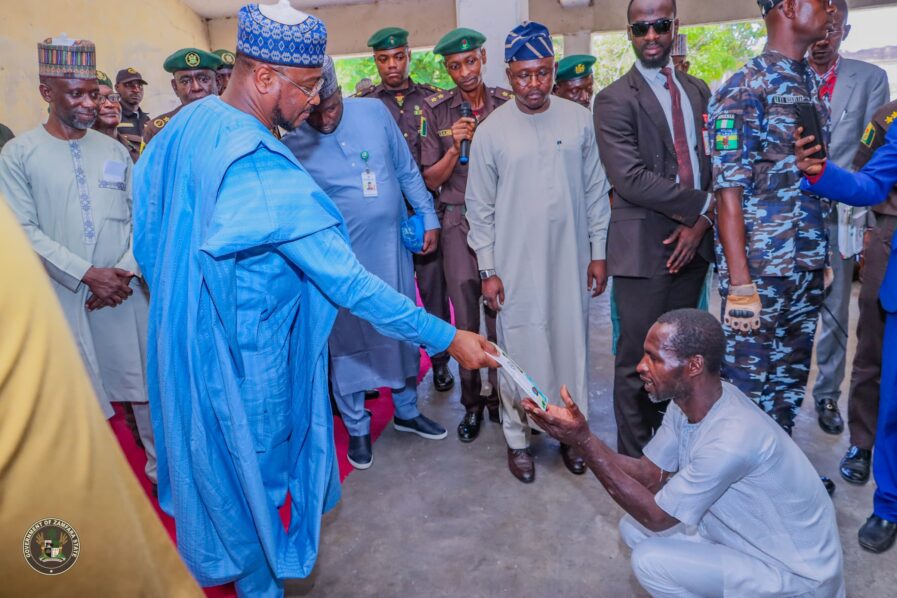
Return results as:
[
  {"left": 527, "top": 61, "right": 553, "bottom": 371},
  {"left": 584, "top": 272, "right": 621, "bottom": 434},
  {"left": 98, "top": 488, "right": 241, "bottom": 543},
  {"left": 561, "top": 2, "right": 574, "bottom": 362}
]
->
[{"left": 282, "top": 57, "right": 446, "bottom": 469}]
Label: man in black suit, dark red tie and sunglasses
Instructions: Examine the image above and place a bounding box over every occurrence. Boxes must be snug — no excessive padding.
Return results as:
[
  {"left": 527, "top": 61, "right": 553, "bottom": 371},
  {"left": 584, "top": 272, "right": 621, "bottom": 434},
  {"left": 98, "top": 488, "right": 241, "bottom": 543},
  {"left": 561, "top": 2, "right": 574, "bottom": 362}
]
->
[{"left": 594, "top": 0, "right": 713, "bottom": 457}]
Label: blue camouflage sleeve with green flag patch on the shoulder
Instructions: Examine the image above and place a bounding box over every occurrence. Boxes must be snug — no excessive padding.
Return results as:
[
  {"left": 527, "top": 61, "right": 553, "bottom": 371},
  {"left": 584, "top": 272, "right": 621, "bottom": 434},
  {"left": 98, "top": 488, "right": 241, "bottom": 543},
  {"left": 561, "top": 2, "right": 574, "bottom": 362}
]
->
[{"left": 708, "top": 84, "right": 762, "bottom": 191}]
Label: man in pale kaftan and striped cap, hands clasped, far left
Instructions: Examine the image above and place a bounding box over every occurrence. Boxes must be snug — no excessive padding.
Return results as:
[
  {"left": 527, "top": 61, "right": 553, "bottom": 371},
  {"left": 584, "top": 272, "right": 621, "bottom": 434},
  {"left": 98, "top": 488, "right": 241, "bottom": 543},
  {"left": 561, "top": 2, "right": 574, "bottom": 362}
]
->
[{"left": 0, "top": 38, "right": 156, "bottom": 482}]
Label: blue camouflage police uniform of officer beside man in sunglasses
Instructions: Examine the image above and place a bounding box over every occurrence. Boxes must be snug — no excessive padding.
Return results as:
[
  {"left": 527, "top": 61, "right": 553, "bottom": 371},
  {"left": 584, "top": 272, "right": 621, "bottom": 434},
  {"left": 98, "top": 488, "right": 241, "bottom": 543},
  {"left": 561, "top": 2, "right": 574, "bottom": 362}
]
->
[{"left": 709, "top": 50, "right": 829, "bottom": 430}]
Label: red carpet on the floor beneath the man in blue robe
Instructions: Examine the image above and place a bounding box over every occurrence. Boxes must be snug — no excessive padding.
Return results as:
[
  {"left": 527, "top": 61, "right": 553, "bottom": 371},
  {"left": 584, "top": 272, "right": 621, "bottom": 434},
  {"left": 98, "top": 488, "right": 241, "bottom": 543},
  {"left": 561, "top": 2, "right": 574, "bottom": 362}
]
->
[{"left": 109, "top": 290, "right": 430, "bottom": 598}]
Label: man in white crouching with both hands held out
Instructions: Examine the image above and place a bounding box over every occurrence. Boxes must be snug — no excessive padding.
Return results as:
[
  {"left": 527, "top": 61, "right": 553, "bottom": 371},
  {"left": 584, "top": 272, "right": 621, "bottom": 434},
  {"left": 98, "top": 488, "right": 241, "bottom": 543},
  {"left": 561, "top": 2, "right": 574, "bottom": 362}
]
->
[{"left": 524, "top": 309, "right": 845, "bottom": 596}]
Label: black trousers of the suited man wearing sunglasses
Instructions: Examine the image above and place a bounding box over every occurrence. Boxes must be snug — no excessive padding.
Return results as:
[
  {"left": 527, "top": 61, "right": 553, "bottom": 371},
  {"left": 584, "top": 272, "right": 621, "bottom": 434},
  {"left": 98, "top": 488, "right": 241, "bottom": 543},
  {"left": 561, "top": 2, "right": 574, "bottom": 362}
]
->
[{"left": 613, "top": 255, "right": 709, "bottom": 458}]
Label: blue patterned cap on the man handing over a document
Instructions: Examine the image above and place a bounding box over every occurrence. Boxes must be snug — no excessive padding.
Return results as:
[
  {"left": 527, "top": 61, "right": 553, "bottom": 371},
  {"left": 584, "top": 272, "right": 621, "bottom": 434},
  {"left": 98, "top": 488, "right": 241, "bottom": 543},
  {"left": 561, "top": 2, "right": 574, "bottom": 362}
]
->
[{"left": 237, "top": 4, "right": 327, "bottom": 68}]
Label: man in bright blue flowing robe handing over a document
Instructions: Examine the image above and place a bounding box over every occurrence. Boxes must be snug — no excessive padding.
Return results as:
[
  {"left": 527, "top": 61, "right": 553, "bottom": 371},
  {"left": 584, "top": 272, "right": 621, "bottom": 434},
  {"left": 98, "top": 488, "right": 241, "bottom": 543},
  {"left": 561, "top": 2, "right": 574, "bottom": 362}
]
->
[{"left": 134, "top": 4, "right": 487, "bottom": 597}]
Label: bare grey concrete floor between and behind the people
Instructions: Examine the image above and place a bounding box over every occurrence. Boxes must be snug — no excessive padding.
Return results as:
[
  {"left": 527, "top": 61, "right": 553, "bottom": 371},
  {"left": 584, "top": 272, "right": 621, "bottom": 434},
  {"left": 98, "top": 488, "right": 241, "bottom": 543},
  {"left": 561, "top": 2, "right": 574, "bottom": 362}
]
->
[{"left": 287, "top": 288, "right": 897, "bottom": 597}]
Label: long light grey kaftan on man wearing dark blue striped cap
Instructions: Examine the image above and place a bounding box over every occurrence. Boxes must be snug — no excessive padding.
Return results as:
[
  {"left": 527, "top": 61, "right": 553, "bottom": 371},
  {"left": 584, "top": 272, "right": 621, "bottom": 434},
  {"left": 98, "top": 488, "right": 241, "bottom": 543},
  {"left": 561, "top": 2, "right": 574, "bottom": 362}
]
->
[{"left": 466, "top": 98, "right": 610, "bottom": 449}]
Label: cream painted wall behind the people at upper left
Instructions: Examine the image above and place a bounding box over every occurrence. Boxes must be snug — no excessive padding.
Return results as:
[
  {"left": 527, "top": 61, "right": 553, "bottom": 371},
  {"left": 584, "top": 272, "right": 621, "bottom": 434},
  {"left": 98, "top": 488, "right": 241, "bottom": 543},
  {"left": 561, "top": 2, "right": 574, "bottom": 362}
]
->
[{"left": 0, "top": 0, "right": 210, "bottom": 133}]
